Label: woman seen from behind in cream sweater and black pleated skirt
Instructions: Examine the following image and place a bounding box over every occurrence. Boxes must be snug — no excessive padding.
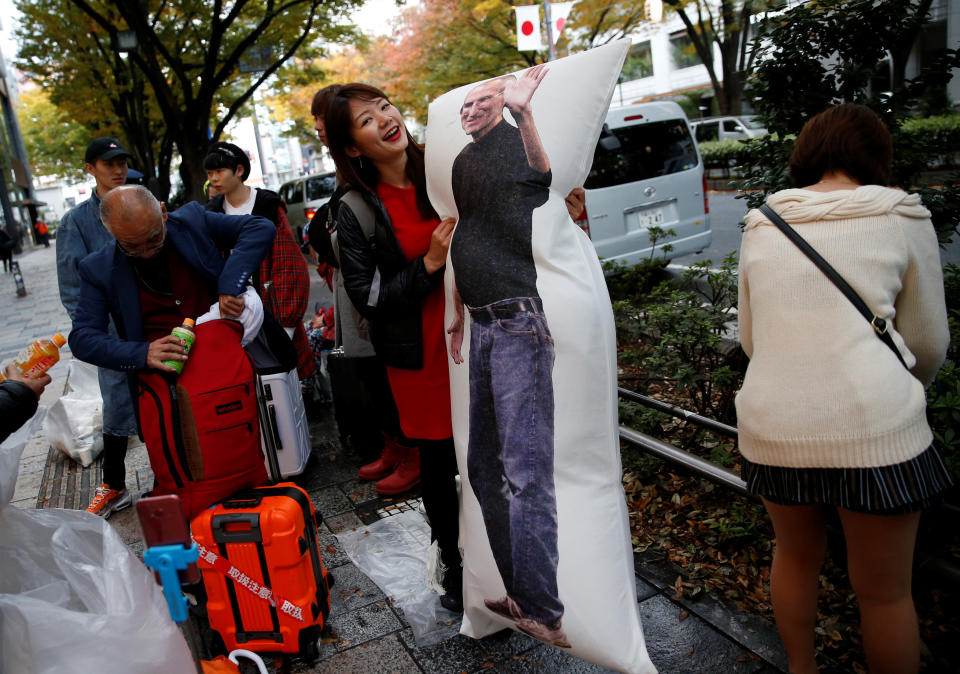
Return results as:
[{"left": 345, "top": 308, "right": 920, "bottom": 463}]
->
[{"left": 737, "top": 104, "right": 950, "bottom": 674}]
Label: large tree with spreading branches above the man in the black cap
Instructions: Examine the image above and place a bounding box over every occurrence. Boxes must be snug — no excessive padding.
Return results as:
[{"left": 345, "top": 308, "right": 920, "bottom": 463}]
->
[{"left": 18, "top": 0, "right": 361, "bottom": 198}]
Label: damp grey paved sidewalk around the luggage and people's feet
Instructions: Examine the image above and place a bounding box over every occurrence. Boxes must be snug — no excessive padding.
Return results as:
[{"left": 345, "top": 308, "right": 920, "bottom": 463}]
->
[{"left": 0, "top": 239, "right": 792, "bottom": 674}]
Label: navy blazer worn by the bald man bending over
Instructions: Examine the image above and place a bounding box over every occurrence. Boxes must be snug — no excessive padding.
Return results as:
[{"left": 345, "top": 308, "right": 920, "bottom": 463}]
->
[{"left": 69, "top": 202, "right": 276, "bottom": 378}]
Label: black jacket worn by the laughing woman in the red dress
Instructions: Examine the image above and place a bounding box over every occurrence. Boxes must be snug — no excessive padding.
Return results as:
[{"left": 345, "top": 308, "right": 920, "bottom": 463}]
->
[{"left": 337, "top": 188, "right": 443, "bottom": 370}]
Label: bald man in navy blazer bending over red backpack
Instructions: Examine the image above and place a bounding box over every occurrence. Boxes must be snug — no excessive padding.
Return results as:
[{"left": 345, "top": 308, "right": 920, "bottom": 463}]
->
[{"left": 69, "top": 185, "right": 276, "bottom": 406}]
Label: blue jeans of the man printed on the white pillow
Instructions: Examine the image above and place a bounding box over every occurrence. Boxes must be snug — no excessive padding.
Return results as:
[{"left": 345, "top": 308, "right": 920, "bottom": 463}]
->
[{"left": 467, "top": 298, "right": 563, "bottom": 625}]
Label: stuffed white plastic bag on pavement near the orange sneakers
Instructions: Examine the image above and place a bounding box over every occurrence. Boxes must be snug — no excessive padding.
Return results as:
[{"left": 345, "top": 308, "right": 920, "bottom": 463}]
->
[{"left": 43, "top": 360, "right": 103, "bottom": 467}]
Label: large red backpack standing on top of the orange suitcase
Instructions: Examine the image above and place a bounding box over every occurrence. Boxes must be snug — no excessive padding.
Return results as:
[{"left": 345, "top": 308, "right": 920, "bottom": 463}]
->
[{"left": 139, "top": 320, "right": 267, "bottom": 519}]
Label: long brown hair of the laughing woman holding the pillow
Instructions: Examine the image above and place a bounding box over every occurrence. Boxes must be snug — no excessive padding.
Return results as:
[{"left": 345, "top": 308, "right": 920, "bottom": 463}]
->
[{"left": 323, "top": 82, "right": 437, "bottom": 219}]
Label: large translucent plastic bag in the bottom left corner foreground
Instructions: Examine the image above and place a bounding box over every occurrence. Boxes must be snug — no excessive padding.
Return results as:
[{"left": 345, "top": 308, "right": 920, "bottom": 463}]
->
[{"left": 0, "top": 412, "right": 194, "bottom": 674}]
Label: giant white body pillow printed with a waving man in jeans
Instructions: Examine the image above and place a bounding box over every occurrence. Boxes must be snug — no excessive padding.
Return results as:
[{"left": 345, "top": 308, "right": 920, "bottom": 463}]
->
[{"left": 426, "top": 40, "right": 655, "bottom": 672}]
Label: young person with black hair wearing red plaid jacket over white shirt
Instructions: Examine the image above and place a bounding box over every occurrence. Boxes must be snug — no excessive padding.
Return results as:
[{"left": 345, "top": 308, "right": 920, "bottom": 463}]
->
[{"left": 203, "top": 142, "right": 316, "bottom": 381}]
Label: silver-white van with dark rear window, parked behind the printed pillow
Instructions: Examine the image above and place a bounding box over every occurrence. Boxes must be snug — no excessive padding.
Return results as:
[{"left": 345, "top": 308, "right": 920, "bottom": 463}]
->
[{"left": 577, "top": 102, "right": 712, "bottom": 265}]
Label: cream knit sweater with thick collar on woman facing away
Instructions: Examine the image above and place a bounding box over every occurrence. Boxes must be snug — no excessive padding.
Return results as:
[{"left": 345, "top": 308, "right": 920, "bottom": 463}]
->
[{"left": 736, "top": 185, "right": 949, "bottom": 468}]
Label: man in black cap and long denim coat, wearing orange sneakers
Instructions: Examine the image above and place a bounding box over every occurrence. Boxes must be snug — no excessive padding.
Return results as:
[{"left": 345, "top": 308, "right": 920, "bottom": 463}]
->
[{"left": 57, "top": 138, "right": 137, "bottom": 517}]
